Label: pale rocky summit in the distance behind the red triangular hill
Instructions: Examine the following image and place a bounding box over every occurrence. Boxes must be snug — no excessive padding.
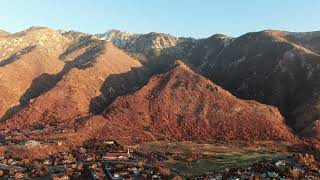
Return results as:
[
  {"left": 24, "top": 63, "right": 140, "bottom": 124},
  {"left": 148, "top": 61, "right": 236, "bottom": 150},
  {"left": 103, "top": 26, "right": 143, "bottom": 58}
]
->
[{"left": 97, "top": 30, "right": 197, "bottom": 72}]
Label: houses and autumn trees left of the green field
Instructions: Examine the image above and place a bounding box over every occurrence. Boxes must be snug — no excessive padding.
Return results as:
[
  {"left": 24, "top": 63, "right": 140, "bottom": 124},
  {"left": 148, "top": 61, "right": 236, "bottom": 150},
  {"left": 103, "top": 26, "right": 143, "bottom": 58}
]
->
[{"left": 0, "top": 140, "right": 172, "bottom": 180}]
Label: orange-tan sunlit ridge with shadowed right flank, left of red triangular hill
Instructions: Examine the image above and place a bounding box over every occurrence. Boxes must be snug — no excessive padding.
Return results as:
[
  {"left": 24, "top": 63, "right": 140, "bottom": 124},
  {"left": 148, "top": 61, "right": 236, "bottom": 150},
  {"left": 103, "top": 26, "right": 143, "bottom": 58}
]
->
[{"left": 2, "top": 41, "right": 149, "bottom": 128}]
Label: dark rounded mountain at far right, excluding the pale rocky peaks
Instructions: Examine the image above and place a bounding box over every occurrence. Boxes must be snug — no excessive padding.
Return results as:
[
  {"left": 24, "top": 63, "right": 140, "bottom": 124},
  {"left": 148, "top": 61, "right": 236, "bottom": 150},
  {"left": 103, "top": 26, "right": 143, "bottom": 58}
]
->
[{"left": 202, "top": 31, "right": 320, "bottom": 134}]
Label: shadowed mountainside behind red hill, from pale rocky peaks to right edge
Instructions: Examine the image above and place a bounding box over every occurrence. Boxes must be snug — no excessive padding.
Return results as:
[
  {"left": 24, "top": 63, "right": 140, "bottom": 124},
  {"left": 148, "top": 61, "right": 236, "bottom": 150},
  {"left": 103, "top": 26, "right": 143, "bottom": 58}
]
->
[{"left": 101, "top": 30, "right": 320, "bottom": 136}]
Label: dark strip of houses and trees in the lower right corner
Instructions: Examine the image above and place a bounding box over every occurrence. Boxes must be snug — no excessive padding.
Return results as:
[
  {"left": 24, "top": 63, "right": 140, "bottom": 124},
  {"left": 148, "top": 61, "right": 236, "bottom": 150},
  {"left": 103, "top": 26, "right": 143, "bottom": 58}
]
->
[{"left": 194, "top": 154, "right": 320, "bottom": 180}]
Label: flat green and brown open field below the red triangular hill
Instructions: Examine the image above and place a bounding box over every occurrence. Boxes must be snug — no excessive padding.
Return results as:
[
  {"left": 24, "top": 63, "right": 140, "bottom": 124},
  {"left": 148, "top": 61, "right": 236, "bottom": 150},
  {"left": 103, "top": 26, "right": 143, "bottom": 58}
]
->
[{"left": 132, "top": 142, "right": 287, "bottom": 176}]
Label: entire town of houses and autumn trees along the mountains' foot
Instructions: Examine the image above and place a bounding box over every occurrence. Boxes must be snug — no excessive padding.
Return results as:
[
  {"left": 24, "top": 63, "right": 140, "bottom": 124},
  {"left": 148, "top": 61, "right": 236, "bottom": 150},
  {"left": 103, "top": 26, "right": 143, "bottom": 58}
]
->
[{"left": 0, "top": 136, "right": 320, "bottom": 180}]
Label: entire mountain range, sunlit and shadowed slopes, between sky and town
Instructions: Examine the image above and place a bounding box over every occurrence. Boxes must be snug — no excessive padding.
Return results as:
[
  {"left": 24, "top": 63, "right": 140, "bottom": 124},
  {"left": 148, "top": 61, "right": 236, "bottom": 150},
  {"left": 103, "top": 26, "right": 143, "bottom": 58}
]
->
[{"left": 0, "top": 27, "right": 320, "bottom": 147}]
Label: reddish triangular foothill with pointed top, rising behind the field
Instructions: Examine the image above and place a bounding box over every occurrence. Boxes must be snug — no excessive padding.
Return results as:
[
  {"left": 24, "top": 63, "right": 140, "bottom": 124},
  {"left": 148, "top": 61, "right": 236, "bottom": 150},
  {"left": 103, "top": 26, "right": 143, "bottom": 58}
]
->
[{"left": 77, "top": 62, "right": 293, "bottom": 143}]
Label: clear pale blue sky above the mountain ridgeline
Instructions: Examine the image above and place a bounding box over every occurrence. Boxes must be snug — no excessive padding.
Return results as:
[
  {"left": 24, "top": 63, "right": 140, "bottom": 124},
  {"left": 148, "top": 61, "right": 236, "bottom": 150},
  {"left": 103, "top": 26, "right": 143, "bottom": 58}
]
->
[{"left": 0, "top": 0, "right": 320, "bottom": 37}]
